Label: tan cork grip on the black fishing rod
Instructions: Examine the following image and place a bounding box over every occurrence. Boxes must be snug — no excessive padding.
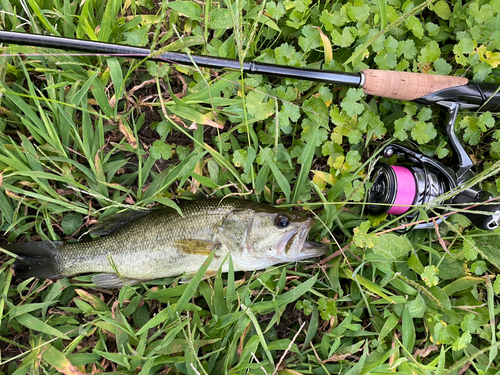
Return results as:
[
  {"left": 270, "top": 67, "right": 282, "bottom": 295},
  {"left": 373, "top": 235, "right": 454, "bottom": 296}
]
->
[{"left": 363, "top": 69, "right": 469, "bottom": 100}]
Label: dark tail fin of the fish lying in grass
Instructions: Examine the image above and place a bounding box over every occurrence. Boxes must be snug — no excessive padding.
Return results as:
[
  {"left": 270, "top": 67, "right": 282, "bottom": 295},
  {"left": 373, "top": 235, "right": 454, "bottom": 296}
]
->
[{"left": 3, "top": 241, "right": 64, "bottom": 279}]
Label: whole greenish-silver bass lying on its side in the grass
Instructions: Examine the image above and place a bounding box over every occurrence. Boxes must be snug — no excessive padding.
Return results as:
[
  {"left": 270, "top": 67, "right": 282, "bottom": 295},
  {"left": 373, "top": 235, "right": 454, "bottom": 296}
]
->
[{"left": 4, "top": 198, "right": 328, "bottom": 288}]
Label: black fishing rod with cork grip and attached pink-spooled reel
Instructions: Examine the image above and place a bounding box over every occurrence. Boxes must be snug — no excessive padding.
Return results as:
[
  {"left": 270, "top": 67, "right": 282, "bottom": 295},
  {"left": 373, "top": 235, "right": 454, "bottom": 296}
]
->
[{"left": 0, "top": 31, "right": 500, "bottom": 230}]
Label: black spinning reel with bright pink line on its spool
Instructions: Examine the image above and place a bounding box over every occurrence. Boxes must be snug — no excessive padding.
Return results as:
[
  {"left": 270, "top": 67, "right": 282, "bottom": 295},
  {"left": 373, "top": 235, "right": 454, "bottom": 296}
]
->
[{"left": 367, "top": 97, "right": 500, "bottom": 230}]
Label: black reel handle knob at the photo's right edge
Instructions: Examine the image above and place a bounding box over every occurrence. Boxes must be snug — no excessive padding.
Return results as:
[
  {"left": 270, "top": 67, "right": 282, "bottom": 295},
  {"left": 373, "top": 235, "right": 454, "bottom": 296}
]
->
[{"left": 452, "top": 190, "right": 500, "bottom": 230}]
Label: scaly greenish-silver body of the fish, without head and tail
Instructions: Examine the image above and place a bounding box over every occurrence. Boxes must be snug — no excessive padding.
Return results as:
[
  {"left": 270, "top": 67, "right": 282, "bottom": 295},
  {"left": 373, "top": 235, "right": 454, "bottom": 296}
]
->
[{"left": 56, "top": 205, "right": 230, "bottom": 279}]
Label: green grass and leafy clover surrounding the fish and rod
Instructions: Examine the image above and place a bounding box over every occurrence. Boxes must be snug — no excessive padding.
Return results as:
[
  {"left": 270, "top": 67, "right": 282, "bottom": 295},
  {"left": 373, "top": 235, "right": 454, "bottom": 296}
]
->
[{"left": 0, "top": 0, "right": 500, "bottom": 375}]
